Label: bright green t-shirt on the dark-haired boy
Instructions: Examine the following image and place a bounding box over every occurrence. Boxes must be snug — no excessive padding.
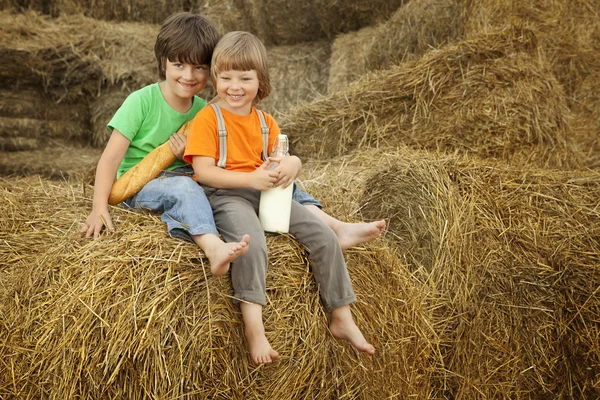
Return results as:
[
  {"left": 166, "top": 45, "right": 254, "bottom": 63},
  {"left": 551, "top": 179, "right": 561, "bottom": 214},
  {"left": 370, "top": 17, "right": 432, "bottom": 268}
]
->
[{"left": 108, "top": 83, "right": 206, "bottom": 178}]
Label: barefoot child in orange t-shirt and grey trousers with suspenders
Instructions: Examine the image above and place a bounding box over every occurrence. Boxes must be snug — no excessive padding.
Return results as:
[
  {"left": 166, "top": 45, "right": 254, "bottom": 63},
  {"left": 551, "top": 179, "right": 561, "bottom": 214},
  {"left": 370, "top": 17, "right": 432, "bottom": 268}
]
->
[{"left": 184, "top": 32, "right": 375, "bottom": 364}]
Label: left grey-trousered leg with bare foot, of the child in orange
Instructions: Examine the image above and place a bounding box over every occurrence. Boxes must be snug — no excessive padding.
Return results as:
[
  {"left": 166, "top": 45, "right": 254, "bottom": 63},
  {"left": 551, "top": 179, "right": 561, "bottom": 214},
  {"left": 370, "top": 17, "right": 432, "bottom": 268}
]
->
[{"left": 208, "top": 189, "right": 279, "bottom": 364}]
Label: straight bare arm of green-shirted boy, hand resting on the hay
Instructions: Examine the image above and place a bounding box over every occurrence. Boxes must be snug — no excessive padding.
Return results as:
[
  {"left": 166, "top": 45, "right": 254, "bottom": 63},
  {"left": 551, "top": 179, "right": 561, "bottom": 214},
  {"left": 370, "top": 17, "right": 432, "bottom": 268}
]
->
[{"left": 80, "top": 129, "right": 130, "bottom": 238}]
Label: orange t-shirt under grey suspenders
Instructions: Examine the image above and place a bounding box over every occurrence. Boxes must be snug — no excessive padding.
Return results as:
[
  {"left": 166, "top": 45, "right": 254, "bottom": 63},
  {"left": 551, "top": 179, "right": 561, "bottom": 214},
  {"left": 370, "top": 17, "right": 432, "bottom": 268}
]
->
[{"left": 183, "top": 106, "right": 279, "bottom": 172}]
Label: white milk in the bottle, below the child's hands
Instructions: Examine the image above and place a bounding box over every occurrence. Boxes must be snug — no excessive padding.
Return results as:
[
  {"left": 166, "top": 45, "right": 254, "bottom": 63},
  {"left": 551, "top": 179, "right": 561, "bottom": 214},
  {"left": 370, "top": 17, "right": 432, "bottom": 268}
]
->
[{"left": 258, "top": 183, "right": 294, "bottom": 233}]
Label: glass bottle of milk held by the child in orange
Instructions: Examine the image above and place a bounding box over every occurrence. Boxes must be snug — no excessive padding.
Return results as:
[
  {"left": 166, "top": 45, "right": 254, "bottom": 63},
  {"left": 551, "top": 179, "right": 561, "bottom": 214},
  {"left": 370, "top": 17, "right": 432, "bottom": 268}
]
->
[{"left": 258, "top": 135, "right": 294, "bottom": 233}]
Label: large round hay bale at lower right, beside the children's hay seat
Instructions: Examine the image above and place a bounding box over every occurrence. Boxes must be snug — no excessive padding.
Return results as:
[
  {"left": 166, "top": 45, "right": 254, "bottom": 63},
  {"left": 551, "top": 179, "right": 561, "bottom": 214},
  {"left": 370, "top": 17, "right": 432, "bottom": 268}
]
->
[{"left": 361, "top": 149, "right": 600, "bottom": 398}]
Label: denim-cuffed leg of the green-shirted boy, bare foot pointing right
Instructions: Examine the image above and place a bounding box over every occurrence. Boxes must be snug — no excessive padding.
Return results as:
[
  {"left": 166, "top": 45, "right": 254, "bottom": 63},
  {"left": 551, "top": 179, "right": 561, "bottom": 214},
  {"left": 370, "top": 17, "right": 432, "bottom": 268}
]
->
[{"left": 292, "top": 184, "right": 385, "bottom": 250}]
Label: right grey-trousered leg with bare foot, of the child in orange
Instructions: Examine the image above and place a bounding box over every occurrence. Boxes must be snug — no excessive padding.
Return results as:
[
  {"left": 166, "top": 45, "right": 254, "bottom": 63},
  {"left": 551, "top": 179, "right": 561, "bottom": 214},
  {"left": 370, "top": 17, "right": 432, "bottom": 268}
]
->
[{"left": 290, "top": 201, "right": 375, "bottom": 354}]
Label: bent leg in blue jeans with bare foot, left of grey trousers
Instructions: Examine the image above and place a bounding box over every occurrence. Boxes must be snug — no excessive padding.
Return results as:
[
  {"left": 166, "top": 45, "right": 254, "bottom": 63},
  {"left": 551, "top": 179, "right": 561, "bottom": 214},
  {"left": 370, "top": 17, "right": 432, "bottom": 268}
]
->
[{"left": 125, "top": 173, "right": 250, "bottom": 275}]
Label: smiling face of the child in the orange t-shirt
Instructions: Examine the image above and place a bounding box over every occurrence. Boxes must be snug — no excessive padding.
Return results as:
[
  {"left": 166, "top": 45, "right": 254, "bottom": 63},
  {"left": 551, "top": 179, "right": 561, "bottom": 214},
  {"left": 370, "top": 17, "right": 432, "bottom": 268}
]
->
[{"left": 216, "top": 70, "right": 260, "bottom": 115}]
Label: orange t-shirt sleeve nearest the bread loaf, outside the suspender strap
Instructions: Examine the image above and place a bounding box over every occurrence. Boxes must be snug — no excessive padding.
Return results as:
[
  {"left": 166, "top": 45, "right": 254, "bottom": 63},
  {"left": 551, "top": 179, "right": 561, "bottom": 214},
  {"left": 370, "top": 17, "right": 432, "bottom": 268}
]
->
[{"left": 183, "top": 107, "right": 219, "bottom": 164}]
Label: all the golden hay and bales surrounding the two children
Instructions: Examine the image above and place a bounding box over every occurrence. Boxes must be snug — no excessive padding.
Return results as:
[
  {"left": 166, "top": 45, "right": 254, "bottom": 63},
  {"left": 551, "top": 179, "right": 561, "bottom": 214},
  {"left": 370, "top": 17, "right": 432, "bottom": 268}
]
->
[{"left": 0, "top": 0, "right": 600, "bottom": 399}]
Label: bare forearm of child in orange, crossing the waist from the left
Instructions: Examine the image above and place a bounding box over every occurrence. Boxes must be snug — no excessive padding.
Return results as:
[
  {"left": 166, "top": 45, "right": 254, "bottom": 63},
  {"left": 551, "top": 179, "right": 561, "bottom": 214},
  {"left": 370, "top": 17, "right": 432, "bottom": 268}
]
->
[{"left": 192, "top": 156, "right": 279, "bottom": 191}]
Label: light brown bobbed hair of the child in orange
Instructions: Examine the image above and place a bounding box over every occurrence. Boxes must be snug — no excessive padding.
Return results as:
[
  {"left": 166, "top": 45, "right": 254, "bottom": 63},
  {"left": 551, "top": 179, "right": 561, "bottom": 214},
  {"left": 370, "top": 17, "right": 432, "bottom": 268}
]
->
[{"left": 210, "top": 31, "right": 271, "bottom": 104}]
